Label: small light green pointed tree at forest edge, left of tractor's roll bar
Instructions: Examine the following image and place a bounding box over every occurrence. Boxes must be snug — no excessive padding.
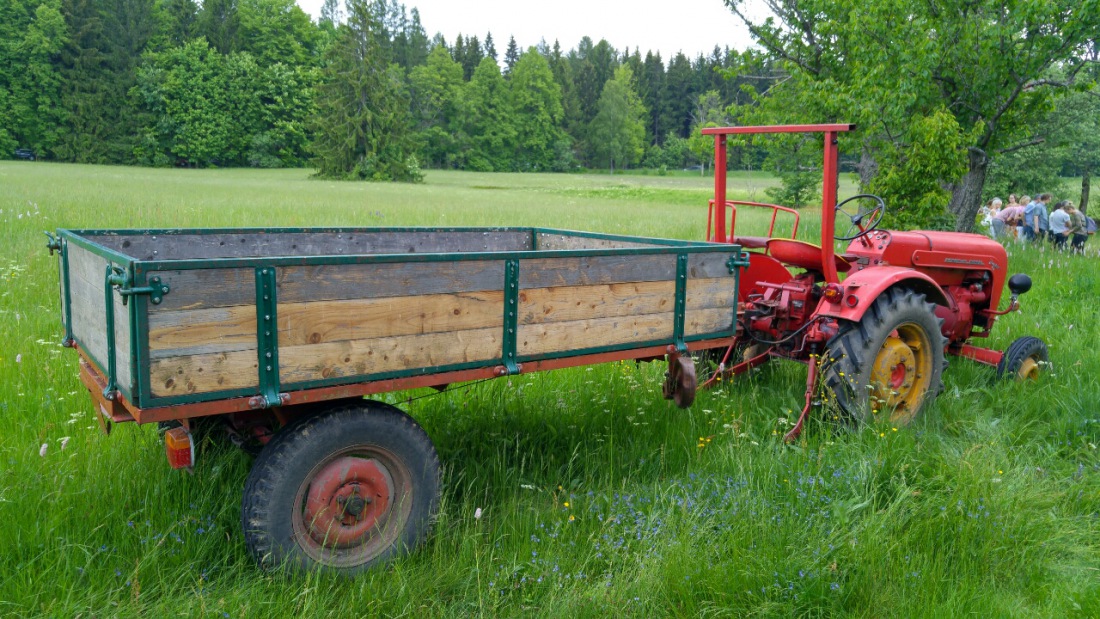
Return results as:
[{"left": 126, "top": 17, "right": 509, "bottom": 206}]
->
[{"left": 592, "top": 66, "right": 646, "bottom": 174}]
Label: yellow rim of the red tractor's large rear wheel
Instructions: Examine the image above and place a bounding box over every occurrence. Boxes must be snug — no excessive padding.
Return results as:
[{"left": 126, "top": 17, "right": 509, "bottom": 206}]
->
[{"left": 868, "top": 322, "right": 932, "bottom": 423}]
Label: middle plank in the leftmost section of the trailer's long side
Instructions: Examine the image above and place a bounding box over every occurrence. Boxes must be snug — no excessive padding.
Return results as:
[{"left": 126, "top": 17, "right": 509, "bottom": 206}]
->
[{"left": 149, "top": 303, "right": 257, "bottom": 360}]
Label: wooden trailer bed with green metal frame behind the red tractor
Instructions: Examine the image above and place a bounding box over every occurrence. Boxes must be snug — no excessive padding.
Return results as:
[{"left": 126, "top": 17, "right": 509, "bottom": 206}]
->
[{"left": 56, "top": 229, "right": 745, "bottom": 422}]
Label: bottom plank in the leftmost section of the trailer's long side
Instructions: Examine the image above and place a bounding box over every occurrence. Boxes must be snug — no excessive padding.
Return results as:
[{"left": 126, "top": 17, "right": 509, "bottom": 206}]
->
[{"left": 150, "top": 350, "right": 260, "bottom": 397}]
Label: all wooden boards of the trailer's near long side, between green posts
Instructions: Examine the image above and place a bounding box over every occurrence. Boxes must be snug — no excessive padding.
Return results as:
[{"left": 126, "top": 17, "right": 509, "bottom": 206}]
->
[{"left": 130, "top": 245, "right": 737, "bottom": 397}]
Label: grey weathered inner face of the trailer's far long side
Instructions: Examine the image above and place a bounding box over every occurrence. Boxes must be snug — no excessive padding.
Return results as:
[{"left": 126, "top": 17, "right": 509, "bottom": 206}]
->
[{"left": 95, "top": 230, "right": 531, "bottom": 261}]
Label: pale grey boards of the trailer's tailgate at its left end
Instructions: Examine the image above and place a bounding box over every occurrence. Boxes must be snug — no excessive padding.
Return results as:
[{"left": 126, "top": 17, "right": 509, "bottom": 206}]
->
[{"left": 66, "top": 243, "right": 133, "bottom": 389}]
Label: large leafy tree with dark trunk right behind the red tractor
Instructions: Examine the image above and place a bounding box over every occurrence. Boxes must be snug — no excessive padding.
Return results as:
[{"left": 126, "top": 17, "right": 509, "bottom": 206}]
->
[{"left": 727, "top": 0, "right": 1100, "bottom": 230}]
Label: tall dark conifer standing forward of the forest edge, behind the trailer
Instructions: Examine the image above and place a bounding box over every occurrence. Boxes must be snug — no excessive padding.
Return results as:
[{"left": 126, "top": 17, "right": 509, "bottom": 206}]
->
[{"left": 312, "top": 0, "right": 421, "bottom": 181}]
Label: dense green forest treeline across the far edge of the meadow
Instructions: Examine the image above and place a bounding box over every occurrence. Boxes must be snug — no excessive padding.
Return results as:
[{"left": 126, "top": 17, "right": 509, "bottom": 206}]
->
[{"left": 0, "top": 0, "right": 769, "bottom": 171}]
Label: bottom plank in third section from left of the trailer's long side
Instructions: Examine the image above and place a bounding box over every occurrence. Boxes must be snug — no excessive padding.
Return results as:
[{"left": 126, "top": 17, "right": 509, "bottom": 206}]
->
[{"left": 516, "top": 311, "right": 673, "bottom": 356}]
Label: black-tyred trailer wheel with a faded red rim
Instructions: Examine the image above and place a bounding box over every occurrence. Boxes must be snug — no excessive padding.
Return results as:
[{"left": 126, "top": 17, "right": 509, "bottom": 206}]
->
[{"left": 241, "top": 400, "right": 440, "bottom": 575}]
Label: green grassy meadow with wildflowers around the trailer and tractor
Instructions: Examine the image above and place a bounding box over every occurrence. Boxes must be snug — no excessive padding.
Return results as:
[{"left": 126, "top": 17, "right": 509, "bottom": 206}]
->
[{"left": 0, "top": 162, "right": 1100, "bottom": 617}]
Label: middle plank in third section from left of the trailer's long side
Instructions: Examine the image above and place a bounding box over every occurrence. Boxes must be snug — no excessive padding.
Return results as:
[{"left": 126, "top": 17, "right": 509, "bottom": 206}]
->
[{"left": 519, "top": 280, "right": 677, "bottom": 324}]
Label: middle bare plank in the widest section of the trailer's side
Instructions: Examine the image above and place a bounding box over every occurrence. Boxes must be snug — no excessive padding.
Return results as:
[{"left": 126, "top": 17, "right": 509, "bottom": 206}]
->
[{"left": 276, "top": 292, "right": 504, "bottom": 346}]
